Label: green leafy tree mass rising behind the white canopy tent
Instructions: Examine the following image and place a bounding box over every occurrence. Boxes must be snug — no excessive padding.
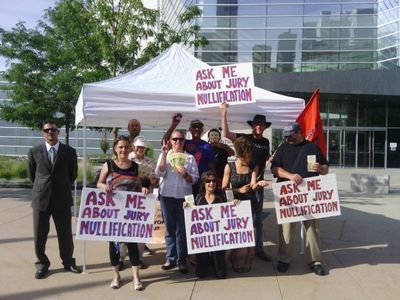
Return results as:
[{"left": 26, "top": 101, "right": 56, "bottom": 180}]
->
[{"left": 0, "top": 0, "right": 207, "bottom": 143}]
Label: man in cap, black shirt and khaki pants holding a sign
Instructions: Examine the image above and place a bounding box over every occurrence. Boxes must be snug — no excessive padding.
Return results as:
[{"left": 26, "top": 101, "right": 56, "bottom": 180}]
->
[{"left": 271, "top": 122, "right": 329, "bottom": 276}]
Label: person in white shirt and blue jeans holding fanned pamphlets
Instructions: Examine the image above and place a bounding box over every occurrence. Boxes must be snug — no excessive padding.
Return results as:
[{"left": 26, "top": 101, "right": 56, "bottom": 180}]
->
[{"left": 156, "top": 130, "right": 199, "bottom": 273}]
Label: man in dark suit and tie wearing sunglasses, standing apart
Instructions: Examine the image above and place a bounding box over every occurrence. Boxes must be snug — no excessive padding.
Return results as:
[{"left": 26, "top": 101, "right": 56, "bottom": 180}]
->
[{"left": 28, "top": 122, "right": 82, "bottom": 279}]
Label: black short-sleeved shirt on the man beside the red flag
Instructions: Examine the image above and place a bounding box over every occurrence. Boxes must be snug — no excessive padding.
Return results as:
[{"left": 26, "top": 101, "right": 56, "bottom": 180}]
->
[{"left": 271, "top": 140, "right": 328, "bottom": 182}]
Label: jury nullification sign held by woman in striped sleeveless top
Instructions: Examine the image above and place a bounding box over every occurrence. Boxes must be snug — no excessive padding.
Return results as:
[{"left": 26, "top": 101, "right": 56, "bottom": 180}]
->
[{"left": 76, "top": 188, "right": 156, "bottom": 243}]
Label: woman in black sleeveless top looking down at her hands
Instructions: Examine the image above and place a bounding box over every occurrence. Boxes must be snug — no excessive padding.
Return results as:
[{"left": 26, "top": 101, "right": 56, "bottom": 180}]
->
[{"left": 222, "top": 137, "right": 267, "bottom": 273}]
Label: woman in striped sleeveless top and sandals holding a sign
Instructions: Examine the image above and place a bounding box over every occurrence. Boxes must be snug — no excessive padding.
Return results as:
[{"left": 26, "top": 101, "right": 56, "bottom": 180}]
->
[{"left": 97, "top": 136, "right": 148, "bottom": 291}]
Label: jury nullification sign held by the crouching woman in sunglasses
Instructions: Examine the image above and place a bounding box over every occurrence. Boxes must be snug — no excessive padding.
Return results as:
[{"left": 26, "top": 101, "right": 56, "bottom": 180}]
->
[{"left": 184, "top": 201, "right": 254, "bottom": 254}]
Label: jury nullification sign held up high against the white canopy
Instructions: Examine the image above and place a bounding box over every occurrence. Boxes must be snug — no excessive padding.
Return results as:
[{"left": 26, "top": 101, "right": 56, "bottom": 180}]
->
[{"left": 194, "top": 63, "right": 256, "bottom": 108}]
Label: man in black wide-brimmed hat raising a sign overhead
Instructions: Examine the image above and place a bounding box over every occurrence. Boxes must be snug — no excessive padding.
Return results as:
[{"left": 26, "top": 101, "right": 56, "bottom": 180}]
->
[{"left": 220, "top": 103, "right": 271, "bottom": 261}]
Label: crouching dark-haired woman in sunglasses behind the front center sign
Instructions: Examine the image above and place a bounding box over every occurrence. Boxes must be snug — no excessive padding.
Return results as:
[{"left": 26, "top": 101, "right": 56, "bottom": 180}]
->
[{"left": 184, "top": 171, "right": 227, "bottom": 279}]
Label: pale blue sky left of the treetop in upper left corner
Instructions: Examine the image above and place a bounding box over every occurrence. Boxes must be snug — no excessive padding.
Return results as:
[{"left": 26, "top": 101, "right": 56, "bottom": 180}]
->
[{"left": 0, "top": 0, "right": 56, "bottom": 71}]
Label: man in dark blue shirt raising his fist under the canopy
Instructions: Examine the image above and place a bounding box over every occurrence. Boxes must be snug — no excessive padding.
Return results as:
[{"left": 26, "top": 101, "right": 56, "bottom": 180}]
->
[{"left": 161, "top": 113, "right": 215, "bottom": 197}]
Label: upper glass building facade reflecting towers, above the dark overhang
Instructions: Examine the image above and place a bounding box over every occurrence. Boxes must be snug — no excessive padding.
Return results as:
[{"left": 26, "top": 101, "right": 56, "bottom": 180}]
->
[{"left": 162, "top": 0, "right": 400, "bottom": 73}]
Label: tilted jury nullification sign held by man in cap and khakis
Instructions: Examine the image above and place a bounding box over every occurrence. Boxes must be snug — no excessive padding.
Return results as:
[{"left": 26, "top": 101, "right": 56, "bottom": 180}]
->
[{"left": 272, "top": 174, "right": 341, "bottom": 224}]
